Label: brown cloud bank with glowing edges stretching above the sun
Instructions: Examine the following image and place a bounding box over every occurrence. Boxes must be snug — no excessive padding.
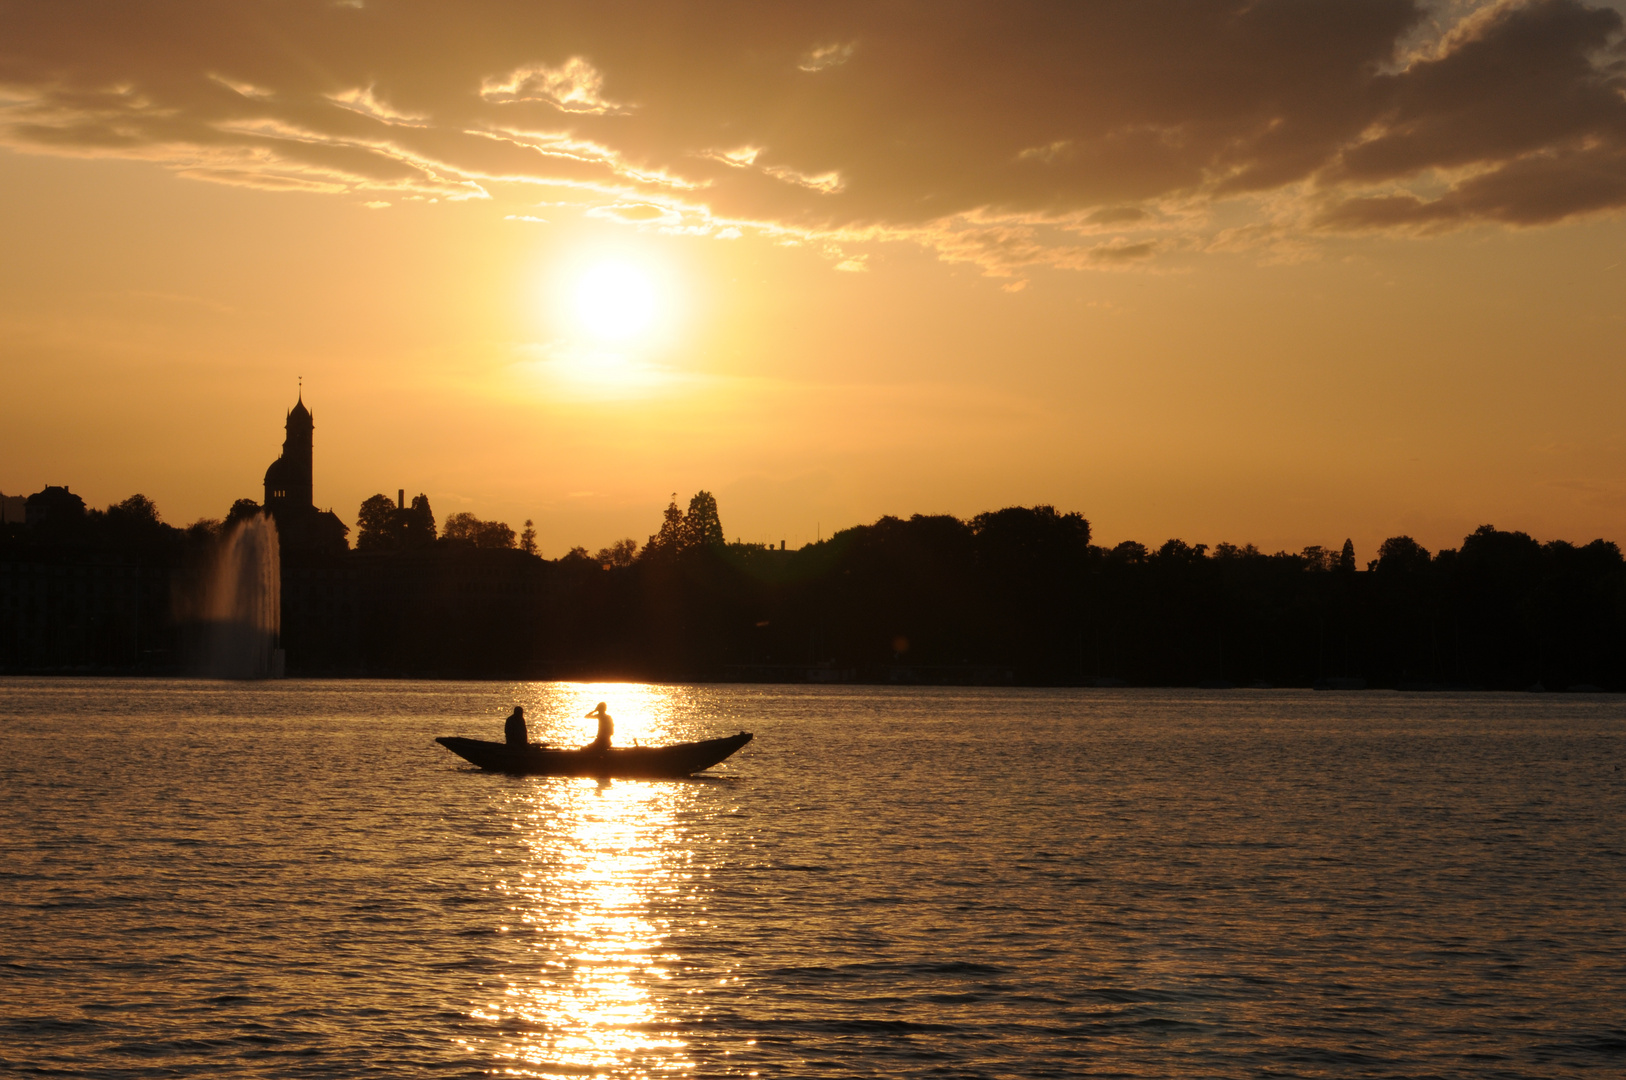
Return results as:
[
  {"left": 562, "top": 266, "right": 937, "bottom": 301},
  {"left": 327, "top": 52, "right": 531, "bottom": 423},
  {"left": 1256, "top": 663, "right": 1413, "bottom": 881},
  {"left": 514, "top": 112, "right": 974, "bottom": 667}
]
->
[{"left": 0, "top": 0, "right": 1626, "bottom": 272}]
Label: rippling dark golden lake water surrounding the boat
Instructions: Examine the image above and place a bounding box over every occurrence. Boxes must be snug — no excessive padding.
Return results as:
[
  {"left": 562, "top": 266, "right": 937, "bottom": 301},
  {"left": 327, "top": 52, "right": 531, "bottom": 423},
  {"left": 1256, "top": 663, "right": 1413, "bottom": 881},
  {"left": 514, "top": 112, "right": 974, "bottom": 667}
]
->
[{"left": 0, "top": 680, "right": 1626, "bottom": 1078}]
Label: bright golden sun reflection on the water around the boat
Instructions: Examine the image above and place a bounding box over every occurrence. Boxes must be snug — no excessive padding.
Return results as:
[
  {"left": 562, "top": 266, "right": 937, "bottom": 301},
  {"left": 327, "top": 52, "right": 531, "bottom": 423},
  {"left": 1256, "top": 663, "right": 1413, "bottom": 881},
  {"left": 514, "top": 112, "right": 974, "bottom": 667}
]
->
[{"left": 465, "top": 683, "right": 747, "bottom": 1078}]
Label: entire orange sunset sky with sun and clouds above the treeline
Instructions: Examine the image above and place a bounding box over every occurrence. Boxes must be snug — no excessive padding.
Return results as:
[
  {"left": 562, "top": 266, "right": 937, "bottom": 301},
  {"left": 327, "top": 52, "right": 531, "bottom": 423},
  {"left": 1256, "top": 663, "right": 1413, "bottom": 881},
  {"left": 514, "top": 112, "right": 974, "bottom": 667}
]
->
[{"left": 0, "top": 0, "right": 1626, "bottom": 561}]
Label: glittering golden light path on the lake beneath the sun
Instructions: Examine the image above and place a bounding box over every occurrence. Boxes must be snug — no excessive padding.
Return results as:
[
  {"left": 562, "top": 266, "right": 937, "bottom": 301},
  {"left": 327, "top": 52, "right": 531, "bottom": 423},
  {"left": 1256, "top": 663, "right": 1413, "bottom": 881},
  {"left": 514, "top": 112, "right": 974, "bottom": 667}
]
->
[{"left": 470, "top": 683, "right": 725, "bottom": 1078}]
